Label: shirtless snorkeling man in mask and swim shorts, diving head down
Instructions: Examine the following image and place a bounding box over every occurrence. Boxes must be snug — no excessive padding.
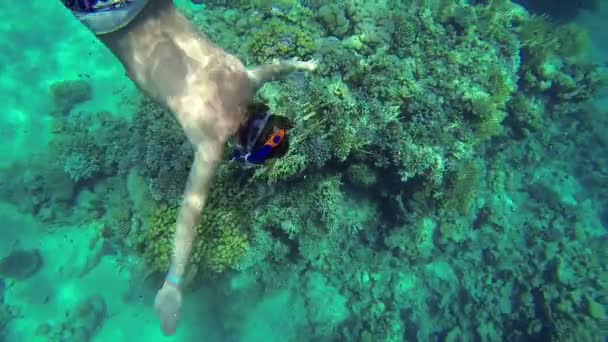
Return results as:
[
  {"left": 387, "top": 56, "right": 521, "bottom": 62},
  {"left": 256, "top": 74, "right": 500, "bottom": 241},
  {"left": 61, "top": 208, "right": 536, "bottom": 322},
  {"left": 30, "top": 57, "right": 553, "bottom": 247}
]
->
[{"left": 62, "top": 0, "right": 316, "bottom": 335}]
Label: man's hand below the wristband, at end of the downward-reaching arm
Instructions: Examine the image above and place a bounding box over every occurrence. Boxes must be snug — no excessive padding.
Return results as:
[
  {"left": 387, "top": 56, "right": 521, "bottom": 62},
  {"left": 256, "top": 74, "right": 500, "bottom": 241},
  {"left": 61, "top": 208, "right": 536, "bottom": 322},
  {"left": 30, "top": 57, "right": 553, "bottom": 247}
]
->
[{"left": 154, "top": 283, "right": 182, "bottom": 336}]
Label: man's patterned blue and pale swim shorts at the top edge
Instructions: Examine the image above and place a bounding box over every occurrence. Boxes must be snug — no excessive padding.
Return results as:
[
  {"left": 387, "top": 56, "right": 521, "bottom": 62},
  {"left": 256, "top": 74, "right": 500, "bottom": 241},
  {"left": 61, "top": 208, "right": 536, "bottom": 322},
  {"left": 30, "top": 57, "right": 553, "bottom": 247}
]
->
[{"left": 61, "top": 0, "right": 148, "bottom": 35}]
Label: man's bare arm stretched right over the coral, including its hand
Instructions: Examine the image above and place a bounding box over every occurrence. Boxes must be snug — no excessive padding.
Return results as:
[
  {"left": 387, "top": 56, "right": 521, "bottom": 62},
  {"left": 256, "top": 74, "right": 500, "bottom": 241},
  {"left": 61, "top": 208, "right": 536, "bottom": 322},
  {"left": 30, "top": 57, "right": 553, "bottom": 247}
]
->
[{"left": 247, "top": 60, "right": 317, "bottom": 94}]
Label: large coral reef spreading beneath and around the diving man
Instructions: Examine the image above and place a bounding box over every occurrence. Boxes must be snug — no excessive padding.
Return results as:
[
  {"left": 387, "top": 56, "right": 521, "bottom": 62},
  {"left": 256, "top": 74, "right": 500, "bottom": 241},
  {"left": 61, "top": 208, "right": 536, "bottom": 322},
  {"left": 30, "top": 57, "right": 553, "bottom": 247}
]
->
[{"left": 2, "top": 0, "right": 608, "bottom": 341}]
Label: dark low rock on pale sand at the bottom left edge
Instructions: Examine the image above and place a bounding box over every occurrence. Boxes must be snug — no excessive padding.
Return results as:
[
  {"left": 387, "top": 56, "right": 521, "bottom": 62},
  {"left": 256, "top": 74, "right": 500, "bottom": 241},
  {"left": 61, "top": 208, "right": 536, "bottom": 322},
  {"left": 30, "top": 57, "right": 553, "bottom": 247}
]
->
[{"left": 36, "top": 296, "right": 108, "bottom": 341}]
